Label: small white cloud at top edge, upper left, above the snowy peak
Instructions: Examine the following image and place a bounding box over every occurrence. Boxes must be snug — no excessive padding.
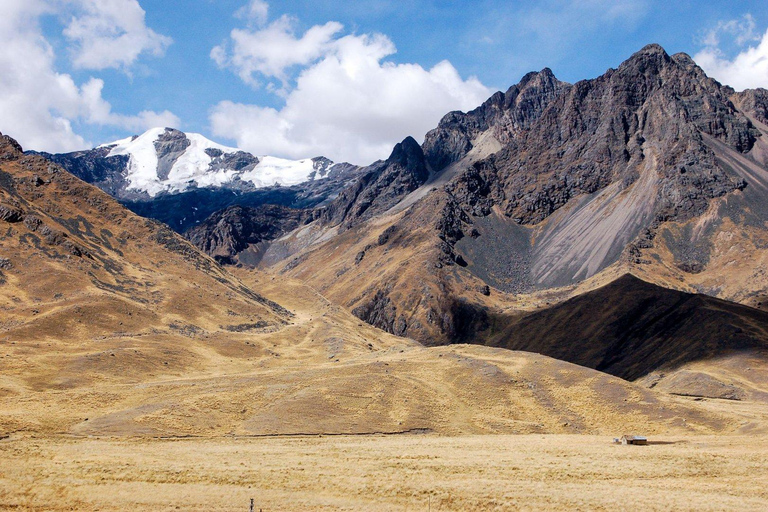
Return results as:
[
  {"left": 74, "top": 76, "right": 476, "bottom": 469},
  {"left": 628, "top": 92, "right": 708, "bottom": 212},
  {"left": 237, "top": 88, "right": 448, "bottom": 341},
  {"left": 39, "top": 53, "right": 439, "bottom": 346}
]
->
[{"left": 64, "top": 0, "right": 172, "bottom": 69}]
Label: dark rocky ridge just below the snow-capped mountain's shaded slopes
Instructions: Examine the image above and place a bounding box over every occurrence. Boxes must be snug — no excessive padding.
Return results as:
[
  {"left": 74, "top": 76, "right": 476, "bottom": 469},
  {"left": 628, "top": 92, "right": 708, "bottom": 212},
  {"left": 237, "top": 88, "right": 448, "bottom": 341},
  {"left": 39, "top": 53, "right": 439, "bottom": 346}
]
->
[{"left": 184, "top": 205, "right": 311, "bottom": 263}]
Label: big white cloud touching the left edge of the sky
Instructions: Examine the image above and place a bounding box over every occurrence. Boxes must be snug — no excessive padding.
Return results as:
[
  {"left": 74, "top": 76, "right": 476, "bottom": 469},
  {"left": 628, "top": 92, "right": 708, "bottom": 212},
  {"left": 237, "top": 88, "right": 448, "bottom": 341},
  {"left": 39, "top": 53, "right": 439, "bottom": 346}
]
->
[{"left": 0, "top": 0, "right": 179, "bottom": 152}]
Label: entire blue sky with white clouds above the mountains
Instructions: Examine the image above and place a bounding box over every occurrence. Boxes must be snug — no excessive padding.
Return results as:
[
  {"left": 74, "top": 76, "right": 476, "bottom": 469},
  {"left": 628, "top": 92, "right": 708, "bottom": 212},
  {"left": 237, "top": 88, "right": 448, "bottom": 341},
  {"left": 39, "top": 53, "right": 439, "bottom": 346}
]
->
[{"left": 0, "top": 0, "right": 768, "bottom": 164}]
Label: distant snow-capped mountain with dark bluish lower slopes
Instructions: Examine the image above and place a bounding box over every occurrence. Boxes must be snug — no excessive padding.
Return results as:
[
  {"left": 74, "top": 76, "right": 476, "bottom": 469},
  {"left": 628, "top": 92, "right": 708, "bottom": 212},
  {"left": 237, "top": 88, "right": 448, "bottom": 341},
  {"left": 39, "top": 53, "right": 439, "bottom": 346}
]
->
[{"left": 33, "top": 128, "right": 356, "bottom": 231}]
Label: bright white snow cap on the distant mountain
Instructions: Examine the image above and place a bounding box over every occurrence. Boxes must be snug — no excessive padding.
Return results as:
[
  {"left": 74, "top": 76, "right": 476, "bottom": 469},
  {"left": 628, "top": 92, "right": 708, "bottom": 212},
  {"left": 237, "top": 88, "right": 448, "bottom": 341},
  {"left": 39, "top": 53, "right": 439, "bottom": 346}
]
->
[{"left": 99, "top": 128, "right": 334, "bottom": 197}]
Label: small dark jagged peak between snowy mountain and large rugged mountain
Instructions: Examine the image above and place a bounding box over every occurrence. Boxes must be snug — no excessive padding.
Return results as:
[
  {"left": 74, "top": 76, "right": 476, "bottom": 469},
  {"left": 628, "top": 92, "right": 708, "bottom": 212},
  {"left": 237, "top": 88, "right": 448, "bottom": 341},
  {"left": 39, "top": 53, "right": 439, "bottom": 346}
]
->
[{"left": 321, "top": 137, "right": 429, "bottom": 227}]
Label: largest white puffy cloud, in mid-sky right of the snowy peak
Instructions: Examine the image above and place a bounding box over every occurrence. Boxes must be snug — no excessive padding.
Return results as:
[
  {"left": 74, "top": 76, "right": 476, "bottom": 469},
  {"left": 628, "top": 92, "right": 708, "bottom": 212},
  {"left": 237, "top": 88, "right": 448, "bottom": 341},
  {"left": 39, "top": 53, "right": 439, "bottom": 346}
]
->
[{"left": 210, "top": 3, "right": 492, "bottom": 164}]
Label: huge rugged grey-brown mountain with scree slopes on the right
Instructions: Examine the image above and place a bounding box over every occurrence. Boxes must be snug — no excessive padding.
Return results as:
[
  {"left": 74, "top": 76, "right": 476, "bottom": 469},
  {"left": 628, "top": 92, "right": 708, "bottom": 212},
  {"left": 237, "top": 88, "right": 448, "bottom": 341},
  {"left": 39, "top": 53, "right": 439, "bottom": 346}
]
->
[{"left": 183, "top": 45, "right": 768, "bottom": 352}]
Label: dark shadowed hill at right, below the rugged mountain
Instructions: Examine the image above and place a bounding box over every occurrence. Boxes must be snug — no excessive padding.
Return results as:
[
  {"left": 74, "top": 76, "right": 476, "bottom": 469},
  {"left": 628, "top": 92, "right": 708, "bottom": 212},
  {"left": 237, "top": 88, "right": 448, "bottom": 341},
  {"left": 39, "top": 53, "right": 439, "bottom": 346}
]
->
[{"left": 489, "top": 274, "right": 768, "bottom": 380}]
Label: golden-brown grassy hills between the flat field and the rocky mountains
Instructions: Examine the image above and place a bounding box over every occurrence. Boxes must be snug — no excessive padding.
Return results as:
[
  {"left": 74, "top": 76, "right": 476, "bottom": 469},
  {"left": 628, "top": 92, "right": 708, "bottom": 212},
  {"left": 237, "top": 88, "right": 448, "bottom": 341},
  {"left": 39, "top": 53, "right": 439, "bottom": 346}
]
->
[{"left": 0, "top": 131, "right": 765, "bottom": 437}]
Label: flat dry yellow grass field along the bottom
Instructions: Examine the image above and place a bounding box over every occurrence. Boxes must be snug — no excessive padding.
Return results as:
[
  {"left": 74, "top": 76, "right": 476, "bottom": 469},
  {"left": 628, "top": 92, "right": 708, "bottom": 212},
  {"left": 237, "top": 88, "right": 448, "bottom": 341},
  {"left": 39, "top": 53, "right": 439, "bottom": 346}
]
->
[{"left": 0, "top": 435, "right": 768, "bottom": 512}]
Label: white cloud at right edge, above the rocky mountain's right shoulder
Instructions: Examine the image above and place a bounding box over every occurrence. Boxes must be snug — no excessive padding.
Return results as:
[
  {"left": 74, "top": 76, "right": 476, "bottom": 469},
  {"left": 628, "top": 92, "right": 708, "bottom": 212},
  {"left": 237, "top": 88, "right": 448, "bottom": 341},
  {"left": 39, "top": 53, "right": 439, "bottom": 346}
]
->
[{"left": 693, "top": 16, "right": 768, "bottom": 91}]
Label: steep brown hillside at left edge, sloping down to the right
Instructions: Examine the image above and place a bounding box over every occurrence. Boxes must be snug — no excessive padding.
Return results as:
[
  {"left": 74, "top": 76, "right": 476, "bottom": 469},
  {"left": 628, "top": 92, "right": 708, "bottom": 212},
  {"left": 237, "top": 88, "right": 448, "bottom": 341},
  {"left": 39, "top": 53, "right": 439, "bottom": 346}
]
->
[{"left": 0, "top": 132, "right": 292, "bottom": 388}]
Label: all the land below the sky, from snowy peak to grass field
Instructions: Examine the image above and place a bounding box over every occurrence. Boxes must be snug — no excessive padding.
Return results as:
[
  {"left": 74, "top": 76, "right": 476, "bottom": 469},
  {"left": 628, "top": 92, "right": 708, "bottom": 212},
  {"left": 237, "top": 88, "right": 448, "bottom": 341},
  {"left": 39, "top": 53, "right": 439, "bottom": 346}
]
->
[{"left": 0, "top": 41, "right": 768, "bottom": 510}]
